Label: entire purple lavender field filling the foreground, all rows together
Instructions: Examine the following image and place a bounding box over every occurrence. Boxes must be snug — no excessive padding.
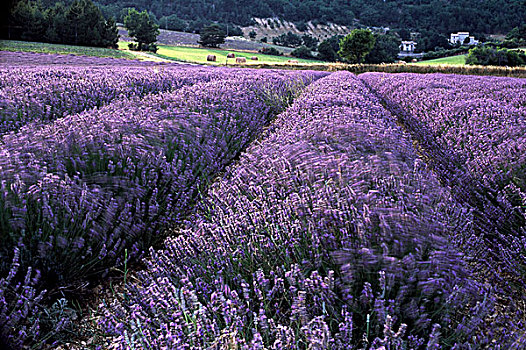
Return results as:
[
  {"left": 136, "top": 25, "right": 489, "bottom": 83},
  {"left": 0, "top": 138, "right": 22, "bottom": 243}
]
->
[{"left": 0, "top": 54, "right": 526, "bottom": 350}]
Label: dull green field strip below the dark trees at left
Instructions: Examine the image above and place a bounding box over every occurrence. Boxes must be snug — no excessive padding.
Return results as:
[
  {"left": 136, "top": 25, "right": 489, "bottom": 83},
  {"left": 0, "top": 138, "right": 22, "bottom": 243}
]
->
[{"left": 0, "top": 40, "right": 136, "bottom": 59}]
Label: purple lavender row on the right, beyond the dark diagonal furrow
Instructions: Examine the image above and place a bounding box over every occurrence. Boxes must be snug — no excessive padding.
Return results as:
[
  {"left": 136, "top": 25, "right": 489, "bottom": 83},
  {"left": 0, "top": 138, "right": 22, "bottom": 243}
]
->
[{"left": 361, "top": 73, "right": 526, "bottom": 297}]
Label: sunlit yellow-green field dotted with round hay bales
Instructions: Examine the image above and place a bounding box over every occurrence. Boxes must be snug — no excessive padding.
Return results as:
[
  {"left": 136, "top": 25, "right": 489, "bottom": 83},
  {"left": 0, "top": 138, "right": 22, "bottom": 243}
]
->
[{"left": 119, "top": 41, "right": 321, "bottom": 64}]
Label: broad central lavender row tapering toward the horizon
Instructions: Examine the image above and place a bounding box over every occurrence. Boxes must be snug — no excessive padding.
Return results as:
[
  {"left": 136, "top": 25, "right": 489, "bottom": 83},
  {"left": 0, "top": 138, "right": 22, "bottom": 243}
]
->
[{"left": 100, "top": 72, "right": 508, "bottom": 349}]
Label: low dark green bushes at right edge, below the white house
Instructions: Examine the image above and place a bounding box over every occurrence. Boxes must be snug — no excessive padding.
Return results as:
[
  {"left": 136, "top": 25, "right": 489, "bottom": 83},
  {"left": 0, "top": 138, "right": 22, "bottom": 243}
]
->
[{"left": 466, "top": 46, "right": 526, "bottom": 67}]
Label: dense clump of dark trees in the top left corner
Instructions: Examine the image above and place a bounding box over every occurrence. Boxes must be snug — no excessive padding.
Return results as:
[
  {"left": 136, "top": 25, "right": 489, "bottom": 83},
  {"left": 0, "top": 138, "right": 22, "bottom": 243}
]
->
[{"left": 3, "top": 0, "right": 119, "bottom": 48}]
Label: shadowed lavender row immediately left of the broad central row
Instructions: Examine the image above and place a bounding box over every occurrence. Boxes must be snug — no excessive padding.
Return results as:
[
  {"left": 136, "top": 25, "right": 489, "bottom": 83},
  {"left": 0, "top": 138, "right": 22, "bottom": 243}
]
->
[{"left": 0, "top": 66, "right": 325, "bottom": 345}]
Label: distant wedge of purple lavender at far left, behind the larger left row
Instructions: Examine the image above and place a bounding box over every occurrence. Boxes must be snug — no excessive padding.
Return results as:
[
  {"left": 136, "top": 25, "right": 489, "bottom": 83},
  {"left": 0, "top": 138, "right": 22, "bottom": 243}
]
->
[{"left": 0, "top": 66, "right": 221, "bottom": 134}]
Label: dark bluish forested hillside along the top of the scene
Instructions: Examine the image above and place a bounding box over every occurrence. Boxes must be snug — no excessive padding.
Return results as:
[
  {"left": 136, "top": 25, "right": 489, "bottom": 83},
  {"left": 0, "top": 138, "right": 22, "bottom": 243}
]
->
[{"left": 92, "top": 0, "right": 526, "bottom": 34}]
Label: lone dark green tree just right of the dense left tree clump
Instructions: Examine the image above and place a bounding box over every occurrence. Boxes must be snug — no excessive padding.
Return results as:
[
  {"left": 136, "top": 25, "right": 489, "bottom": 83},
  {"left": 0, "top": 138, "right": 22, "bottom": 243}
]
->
[{"left": 124, "top": 8, "right": 159, "bottom": 51}]
